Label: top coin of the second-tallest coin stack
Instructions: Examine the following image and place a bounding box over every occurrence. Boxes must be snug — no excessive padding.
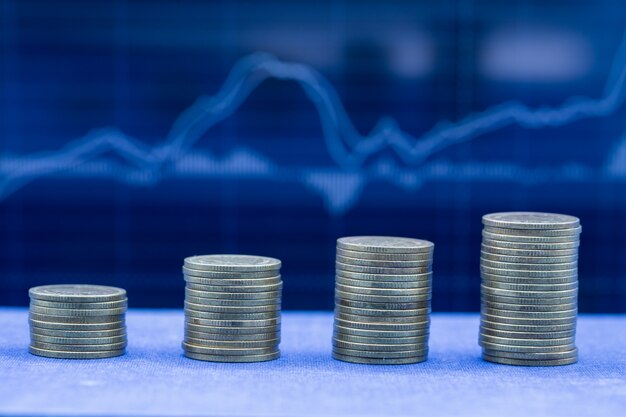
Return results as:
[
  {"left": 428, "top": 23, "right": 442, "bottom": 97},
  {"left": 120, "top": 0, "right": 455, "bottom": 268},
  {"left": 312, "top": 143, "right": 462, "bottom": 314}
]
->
[{"left": 337, "top": 236, "right": 435, "bottom": 253}]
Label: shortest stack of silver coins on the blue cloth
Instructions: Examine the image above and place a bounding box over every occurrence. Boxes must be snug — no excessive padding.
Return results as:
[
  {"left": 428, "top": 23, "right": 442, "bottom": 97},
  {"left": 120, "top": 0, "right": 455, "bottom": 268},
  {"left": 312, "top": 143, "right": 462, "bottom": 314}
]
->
[{"left": 28, "top": 285, "right": 127, "bottom": 359}]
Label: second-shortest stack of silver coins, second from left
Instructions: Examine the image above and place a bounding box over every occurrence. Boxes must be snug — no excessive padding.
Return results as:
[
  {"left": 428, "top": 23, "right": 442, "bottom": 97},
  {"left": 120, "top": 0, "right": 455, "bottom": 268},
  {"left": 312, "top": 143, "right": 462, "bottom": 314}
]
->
[{"left": 182, "top": 255, "right": 283, "bottom": 362}]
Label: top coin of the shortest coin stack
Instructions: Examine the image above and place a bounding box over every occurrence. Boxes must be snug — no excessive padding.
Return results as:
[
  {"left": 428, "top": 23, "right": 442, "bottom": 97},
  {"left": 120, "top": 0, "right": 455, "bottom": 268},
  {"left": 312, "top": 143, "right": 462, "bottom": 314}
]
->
[{"left": 28, "top": 284, "right": 126, "bottom": 303}]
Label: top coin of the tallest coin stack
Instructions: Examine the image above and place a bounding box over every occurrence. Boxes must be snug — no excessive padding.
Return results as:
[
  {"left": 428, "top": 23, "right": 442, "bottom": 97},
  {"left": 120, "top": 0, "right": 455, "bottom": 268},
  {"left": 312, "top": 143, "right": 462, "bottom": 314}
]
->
[{"left": 483, "top": 211, "right": 580, "bottom": 230}]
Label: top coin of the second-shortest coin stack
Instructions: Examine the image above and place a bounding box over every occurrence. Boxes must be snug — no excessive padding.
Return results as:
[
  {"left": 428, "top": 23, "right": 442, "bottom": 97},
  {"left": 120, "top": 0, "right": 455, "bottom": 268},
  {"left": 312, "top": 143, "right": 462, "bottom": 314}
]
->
[{"left": 184, "top": 254, "right": 281, "bottom": 272}]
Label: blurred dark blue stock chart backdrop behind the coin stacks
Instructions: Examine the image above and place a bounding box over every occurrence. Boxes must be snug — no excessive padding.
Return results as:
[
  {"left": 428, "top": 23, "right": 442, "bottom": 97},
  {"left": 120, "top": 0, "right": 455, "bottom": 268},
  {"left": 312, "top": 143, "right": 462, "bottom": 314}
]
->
[{"left": 0, "top": 0, "right": 626, "bottom": 312}]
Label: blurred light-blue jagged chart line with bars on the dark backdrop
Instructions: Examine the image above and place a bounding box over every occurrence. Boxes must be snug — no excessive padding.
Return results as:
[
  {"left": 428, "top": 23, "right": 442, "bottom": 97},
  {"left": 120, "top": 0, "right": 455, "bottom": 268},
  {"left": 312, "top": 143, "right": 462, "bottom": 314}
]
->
[{"left": 0, "top": 28, "right": 626, "bottom": 212}]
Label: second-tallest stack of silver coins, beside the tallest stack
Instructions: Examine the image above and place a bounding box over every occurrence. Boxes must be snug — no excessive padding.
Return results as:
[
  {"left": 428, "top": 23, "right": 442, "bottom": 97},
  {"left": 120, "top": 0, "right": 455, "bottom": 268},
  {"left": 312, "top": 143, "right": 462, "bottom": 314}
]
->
[{"left": 333, "top": 236, "right": 434, "bottom": 365}]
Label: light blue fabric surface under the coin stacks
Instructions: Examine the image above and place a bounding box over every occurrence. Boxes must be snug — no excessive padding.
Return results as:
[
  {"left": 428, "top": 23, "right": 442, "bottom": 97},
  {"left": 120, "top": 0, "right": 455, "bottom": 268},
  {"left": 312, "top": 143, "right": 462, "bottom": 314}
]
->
[{"left": 0, "top": 308, "right": 626, "bottom": 417}]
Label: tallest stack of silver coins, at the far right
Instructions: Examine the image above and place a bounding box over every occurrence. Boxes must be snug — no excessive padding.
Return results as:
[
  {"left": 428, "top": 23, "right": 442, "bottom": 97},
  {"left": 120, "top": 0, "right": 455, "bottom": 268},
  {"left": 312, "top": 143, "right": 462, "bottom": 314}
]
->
[{"left": 479, "top": 212, "right": 581, "bottom": 366}]
